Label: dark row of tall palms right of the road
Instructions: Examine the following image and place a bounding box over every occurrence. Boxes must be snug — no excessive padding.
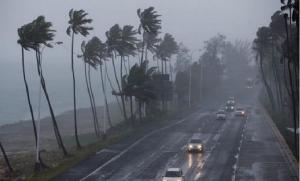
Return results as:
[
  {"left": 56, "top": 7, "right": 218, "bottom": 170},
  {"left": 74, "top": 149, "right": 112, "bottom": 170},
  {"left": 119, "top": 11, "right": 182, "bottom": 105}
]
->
[{"left": 253, "top": 0, "right": 299, "bottom": 158}]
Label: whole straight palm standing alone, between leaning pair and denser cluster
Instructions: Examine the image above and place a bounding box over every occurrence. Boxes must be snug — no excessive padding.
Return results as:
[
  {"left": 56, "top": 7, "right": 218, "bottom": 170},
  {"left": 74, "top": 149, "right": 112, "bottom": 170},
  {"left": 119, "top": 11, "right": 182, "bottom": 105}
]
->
[{"left": 67, "top": 9, "right": 93, "bottom": 148}]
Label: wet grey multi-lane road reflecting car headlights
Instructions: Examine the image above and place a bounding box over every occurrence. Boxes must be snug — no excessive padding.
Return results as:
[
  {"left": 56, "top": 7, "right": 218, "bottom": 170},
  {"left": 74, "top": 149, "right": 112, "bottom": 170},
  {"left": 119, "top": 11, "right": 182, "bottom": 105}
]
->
[{"left": 55, "top": 99, "right": 297, "bottom": 181}]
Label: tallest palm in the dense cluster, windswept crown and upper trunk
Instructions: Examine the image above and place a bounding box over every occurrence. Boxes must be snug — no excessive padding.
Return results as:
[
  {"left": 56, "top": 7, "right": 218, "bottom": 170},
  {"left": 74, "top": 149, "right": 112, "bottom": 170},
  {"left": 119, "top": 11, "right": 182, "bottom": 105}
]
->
[{"left": 137, "top": 7, "right": 161, "bottom": 64}]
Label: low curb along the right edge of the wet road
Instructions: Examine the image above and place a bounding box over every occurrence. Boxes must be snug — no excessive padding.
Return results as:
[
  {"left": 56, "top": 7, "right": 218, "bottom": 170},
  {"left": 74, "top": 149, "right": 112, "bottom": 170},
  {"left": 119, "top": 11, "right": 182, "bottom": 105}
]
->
[{"left": 261, "top": 106, "right": 299, "bottom": 178}]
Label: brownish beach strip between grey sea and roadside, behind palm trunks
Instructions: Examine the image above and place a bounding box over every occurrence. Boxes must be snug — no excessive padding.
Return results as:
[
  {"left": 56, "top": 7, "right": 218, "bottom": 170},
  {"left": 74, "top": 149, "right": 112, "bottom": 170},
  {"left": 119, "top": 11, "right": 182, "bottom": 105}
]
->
[{"left": 0, "top": 103, "right": 122, "bottom": 153}]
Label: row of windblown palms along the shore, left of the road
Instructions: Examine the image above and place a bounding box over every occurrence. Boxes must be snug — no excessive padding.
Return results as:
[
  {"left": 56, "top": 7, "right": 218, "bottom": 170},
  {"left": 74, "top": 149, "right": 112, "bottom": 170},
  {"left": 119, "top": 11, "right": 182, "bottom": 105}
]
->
[{"left": 5, "top": 7, "right": 177, "bottom": 172}]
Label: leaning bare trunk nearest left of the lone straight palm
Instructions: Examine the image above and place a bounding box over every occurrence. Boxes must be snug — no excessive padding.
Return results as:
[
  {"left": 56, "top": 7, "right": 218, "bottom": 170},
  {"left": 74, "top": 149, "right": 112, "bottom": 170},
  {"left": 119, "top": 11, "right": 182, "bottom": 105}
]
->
[{"left": 36, "top": 50, "right": 68, "bottom": 156}]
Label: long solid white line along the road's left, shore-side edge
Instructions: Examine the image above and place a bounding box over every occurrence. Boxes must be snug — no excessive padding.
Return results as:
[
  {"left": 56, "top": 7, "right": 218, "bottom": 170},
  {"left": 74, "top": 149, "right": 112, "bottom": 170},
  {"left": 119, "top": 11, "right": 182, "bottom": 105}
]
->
[{"left": 80, "top": 113, "right": 206, "bottom": 181}]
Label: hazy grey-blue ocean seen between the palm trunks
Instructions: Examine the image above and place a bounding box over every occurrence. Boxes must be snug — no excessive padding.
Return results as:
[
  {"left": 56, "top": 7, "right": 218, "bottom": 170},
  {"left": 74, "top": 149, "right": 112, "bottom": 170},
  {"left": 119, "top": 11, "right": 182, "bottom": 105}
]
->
[{"left": 0, "top": 57, "right": 114, "bottom": 125}]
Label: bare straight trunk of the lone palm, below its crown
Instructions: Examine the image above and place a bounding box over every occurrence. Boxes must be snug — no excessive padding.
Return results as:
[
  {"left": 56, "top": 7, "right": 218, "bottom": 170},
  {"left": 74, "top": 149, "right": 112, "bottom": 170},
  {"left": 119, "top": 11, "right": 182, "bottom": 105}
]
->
[{"left": 71, "top": 32, "right": 81, "bottom": 149}]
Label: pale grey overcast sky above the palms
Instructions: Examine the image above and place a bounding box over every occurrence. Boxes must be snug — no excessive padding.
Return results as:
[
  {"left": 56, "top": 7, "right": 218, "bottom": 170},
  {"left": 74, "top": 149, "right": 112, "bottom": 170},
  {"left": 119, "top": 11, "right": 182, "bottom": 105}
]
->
[{"left": 0, "top": 0, "right": 280, "bottom": 61}]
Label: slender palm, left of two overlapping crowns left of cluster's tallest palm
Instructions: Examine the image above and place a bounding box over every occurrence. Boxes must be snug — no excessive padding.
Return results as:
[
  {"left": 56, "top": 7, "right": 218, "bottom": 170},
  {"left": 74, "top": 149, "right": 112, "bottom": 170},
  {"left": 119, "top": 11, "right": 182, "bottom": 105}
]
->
[{"left": 105, "top": 24, "right": 127, "bottom": 121}]
